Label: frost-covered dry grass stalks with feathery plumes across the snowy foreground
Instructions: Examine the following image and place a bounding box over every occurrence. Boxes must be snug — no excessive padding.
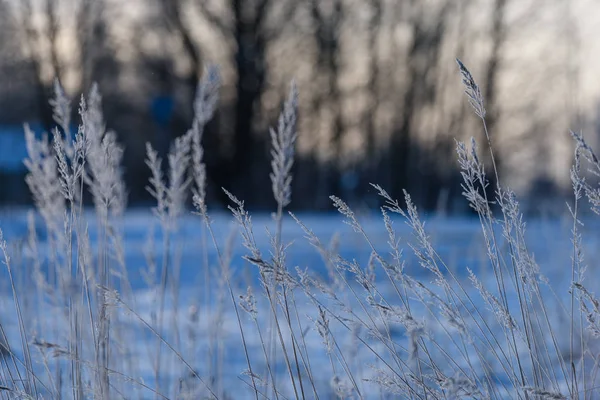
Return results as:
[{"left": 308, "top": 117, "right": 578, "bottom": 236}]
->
[{"left": 0, "top": 61, "right": 600, "bottom": 399}]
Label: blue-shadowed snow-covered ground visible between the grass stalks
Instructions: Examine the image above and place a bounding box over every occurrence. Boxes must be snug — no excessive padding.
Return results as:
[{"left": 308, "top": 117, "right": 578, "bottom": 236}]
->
[{"left": 0, "top": 210, "right": 600, "bottom": 399}]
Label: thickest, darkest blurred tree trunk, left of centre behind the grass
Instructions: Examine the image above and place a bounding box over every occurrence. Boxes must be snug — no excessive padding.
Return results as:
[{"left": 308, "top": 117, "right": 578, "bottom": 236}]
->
[{"left": 216, "top": 0, "right": 297, "bottom": 205}]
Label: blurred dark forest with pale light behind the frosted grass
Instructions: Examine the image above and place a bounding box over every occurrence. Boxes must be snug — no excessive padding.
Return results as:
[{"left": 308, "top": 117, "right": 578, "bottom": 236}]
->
[{"left": 0, "top": 0, "right": 598, "bottom": 212}]
